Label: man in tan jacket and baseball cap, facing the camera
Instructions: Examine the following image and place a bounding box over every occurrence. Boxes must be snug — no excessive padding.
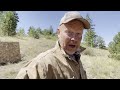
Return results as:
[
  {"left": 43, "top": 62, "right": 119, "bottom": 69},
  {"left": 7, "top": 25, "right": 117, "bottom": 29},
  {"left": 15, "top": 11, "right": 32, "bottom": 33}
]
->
[{"left": 16, "top": 11, "right": 90, "bottom": 79}]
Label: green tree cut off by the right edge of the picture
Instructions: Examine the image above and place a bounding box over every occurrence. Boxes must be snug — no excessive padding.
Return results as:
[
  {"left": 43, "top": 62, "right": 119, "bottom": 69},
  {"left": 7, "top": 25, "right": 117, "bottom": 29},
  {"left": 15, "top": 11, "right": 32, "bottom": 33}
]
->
[{"left": 108, "top": 32, "right": 120, "bottom": 60}]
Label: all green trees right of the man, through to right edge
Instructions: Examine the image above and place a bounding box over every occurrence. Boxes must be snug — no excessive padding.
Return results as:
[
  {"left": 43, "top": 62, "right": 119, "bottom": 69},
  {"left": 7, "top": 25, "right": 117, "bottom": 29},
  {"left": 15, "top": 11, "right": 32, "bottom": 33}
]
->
[{"left": 83, "top": 14, "right": 120, "bottom": 60}]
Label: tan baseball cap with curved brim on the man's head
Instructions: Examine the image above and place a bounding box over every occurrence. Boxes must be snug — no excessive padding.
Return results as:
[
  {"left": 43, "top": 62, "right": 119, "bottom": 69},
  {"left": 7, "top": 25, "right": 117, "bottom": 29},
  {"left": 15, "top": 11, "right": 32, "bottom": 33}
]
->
[{"left": 59, "top": 11, "right": 90, "bottom": 29}]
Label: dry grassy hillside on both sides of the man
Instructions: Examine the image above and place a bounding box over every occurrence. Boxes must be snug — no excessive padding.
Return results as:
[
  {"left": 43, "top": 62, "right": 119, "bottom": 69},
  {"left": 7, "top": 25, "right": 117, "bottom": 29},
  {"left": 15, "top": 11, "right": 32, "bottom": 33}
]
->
[{"left": 0, "top": 37, "right": 120, "bottom": 79}]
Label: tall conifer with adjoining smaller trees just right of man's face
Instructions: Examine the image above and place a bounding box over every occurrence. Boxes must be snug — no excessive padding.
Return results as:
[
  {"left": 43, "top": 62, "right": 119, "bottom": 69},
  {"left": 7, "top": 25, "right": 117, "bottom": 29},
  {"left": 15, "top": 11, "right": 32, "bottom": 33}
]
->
[{"left": 83, "top": 14, "right": 106, "bottom": 49}]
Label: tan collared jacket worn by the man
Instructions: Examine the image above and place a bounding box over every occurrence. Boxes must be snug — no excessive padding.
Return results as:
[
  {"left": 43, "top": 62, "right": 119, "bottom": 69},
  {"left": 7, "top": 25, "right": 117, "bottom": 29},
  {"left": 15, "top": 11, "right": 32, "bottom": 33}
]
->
[{"left": 16, "top": 42, "right": 87, "bottom": 79}]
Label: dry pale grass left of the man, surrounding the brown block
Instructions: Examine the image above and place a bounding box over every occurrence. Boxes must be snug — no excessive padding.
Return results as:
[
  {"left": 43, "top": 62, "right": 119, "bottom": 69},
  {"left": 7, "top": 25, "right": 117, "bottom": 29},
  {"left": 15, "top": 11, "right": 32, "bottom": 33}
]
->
[{"left": 0, "top": 37, "right": 56, "bottom": 79}]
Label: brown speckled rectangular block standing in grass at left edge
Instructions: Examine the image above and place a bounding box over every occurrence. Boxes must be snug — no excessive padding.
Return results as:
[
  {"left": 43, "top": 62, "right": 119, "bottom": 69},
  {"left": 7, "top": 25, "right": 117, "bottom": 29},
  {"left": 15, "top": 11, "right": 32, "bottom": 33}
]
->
[{"left": 0, "top": 42, "right": 21, "bottom": 63}]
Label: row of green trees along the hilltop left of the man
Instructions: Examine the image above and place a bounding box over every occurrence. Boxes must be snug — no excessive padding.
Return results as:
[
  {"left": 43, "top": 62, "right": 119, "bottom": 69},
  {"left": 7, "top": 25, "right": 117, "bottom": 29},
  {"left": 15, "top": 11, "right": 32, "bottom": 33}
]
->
[{"left": 0, "top": 11, "right": 55, "bottom": 39}]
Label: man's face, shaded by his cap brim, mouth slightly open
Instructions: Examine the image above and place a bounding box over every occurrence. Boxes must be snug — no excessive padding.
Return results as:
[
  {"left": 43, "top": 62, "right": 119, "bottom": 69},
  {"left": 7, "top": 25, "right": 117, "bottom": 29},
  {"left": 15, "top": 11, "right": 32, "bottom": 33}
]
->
[{"left": 58, "top": 20, "right": 84, "bottom": 55}]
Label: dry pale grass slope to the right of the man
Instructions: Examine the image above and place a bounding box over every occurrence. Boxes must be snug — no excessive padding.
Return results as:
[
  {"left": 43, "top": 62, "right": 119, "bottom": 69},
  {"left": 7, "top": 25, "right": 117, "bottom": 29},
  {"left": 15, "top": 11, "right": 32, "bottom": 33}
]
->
[{"left": 81, "top": 49, "right": 120, "bottom": 79}]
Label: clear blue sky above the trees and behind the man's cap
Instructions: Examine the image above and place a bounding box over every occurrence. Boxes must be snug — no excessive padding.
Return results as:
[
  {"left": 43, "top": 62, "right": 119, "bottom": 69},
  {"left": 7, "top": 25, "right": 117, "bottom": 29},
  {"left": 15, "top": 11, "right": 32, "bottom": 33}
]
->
[{"left": 17, "top": 11, "right": 120, "bottom": 45}]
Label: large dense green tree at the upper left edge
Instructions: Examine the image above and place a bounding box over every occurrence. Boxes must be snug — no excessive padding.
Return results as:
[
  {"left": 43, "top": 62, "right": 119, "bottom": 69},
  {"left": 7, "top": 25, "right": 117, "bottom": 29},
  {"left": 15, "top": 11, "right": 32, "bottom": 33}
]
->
[{"left": 0, "top": 11, "right": 19, "bottom": 36}]
